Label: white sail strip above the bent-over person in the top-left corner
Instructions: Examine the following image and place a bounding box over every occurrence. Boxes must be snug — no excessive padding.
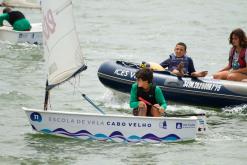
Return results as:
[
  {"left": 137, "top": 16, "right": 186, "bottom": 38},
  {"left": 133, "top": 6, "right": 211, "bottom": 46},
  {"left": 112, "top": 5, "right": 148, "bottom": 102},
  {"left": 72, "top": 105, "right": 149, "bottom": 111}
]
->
[{"left": 2, "top": 0, "right": 40, "bottom": 9}]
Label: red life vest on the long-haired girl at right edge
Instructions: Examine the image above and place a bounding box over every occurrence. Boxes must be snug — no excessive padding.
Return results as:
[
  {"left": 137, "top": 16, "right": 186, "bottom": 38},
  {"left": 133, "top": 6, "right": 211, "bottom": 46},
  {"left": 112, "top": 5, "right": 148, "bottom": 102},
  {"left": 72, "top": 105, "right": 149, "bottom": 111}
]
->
[{"left": 229, "top": 47, "right": 246, "bottom": 68}]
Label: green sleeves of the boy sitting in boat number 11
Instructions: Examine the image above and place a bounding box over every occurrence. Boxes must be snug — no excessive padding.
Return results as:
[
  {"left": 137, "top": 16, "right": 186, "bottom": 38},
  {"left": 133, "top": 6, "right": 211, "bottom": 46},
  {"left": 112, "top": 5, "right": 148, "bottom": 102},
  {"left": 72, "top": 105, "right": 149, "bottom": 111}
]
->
[{"left": 130, "top": 83, "right": 167, "bottom": 109}]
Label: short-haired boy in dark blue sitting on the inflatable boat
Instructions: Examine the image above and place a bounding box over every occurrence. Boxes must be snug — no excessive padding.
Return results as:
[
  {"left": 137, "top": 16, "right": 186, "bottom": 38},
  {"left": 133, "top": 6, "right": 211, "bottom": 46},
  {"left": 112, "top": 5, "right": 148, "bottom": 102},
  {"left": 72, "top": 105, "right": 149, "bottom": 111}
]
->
[{"left": 160, "top": 42, "right": 208, "bottom": 77}]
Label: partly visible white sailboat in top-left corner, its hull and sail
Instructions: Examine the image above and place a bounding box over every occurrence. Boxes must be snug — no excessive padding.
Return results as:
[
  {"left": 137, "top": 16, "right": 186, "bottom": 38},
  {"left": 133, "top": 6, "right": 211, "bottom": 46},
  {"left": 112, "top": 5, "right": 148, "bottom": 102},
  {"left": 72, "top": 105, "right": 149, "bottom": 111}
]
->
[{"left": 0, "top": 0, "right": 43, "bottom": 44}]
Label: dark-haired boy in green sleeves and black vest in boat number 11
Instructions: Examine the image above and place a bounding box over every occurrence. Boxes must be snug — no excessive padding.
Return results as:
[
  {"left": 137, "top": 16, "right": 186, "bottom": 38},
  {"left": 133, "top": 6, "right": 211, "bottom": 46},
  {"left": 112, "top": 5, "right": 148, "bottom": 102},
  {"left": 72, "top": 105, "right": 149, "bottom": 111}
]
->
[{"left": 130, "top": 68, "right": 167, "bottom": 117}]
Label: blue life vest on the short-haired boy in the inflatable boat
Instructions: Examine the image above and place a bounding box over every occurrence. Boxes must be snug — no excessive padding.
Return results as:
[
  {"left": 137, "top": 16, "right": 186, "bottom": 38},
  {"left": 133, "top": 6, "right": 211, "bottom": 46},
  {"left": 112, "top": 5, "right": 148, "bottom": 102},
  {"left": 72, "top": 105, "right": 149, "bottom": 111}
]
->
[{"left": 168, "top": 53, "right": 189, "bottom": 73}]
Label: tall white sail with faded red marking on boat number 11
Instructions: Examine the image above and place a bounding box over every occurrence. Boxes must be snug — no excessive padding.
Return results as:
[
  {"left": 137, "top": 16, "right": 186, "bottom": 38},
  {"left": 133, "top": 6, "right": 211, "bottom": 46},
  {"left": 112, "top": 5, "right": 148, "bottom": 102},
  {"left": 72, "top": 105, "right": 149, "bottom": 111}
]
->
[{"left": 41, "top": 0, "right": 86, "bottom": 88}]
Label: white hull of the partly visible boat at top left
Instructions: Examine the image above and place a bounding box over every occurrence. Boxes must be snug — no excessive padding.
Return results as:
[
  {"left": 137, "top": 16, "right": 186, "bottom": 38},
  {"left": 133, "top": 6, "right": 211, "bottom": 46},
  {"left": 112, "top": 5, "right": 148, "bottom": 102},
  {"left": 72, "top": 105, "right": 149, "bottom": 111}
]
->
[{"left": 0, "top": 23, "right": 43, "bottom": 44}]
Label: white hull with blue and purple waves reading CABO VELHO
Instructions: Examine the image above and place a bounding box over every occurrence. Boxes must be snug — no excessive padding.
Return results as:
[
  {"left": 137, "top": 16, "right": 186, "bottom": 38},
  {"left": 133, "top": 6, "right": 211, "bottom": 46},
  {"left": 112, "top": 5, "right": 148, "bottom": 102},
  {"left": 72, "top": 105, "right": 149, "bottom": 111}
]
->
[{"left": 23, "top": 108, "right": 201, "bottom": 143}]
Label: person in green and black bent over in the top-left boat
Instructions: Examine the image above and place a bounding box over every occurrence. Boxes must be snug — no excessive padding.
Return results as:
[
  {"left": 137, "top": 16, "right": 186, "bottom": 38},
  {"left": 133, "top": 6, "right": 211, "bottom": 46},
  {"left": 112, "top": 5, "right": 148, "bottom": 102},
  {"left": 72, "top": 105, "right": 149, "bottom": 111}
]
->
[{"left": 0, "top": 7, "right": 31, "bottom": 31}]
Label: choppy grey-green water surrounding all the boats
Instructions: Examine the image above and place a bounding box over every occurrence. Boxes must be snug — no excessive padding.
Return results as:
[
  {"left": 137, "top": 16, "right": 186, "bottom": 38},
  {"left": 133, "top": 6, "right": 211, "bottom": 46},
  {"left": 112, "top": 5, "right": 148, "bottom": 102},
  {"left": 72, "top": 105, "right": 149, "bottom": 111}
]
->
[{"left": 0, "top": 0, "right": 247, "bottom": 165}]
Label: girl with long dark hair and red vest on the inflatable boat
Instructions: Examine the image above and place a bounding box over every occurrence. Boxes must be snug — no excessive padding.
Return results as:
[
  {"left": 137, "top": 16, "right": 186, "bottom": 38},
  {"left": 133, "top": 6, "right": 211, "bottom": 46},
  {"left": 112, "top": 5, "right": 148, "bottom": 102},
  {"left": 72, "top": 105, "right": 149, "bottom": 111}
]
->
[{"left": 214, "top": 28, "right": 247, "bottom": 82}]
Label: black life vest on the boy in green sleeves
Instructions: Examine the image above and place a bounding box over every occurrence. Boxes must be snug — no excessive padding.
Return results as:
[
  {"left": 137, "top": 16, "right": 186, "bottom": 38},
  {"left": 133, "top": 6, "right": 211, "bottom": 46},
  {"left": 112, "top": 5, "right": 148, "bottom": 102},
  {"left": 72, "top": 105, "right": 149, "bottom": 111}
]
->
[{"left": 137, "top": 85, "right": 157, "bottom": 110}]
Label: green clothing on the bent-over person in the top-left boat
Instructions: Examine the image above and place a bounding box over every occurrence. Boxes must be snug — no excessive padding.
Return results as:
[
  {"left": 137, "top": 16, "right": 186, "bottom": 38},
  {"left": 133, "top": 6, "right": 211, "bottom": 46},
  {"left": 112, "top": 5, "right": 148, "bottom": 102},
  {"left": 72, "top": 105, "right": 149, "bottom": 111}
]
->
[{"left": 0, "top": 13, "right": 31, "bottom": 31}]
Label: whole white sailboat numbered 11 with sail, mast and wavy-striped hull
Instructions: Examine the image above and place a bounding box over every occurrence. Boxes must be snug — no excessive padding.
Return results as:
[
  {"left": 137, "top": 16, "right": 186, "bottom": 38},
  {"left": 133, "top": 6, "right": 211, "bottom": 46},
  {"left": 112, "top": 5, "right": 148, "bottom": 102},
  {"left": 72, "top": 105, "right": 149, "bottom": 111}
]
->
[{"left": 23, "top": 0, "right": 206, "bottom": 142}]
